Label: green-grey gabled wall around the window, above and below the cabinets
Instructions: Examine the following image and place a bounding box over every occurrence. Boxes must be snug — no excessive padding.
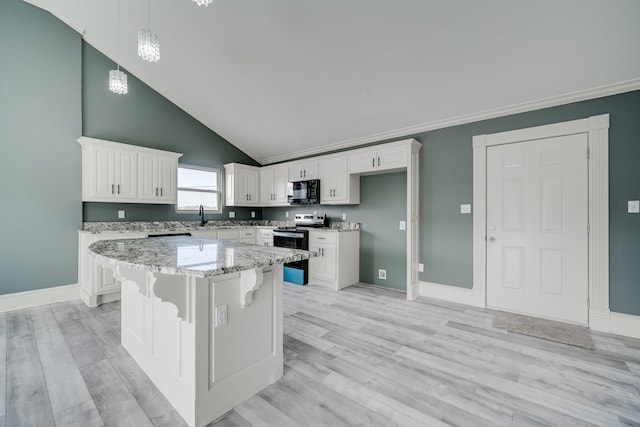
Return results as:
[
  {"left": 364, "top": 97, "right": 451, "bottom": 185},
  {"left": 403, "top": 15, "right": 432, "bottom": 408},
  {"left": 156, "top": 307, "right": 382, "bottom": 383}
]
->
[{"left": 82, "top": 42, "right": 262, "bottom": 221}]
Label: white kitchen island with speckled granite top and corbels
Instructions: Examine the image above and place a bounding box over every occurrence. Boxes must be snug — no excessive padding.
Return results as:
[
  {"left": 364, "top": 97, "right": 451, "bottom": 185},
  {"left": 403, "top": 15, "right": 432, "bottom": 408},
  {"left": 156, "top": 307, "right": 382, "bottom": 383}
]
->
[{"left": 89, "top": 236, "right": 316, "bottom": 426}]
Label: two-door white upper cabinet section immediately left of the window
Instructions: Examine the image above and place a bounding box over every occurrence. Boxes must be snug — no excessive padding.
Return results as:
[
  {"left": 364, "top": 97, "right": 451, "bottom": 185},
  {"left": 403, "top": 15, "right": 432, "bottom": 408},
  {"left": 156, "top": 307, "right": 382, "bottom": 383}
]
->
[{"left": 138, "top": 150, "right": 178, "bottom": 204}]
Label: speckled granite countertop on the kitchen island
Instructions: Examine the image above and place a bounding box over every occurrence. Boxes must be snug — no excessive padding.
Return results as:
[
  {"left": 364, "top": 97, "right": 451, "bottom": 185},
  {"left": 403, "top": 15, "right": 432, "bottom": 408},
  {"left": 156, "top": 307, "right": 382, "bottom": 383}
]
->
[{"left": 89, "top": 236, "right": 318, "bottom": 277}]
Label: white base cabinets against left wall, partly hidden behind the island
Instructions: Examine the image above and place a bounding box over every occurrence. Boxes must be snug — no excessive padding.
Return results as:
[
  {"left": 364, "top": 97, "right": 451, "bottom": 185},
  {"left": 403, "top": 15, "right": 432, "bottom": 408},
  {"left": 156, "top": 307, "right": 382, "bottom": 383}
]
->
[{"left": 78, "top": 231, "right": 147, "bottom": 307}]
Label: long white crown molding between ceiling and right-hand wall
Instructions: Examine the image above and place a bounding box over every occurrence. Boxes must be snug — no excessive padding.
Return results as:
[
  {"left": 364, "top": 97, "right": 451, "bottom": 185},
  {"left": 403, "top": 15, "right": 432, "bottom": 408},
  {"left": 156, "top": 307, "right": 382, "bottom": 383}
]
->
[{"left": 262, "top": 78, "right": 640, "bottom": 165}]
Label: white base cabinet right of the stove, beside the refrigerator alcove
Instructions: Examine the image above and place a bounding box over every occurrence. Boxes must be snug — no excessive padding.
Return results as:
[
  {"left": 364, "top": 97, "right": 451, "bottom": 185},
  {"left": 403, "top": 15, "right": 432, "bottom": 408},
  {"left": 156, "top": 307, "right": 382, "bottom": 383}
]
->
[{"left": 309, "top": 230, "right": 360, "bottom": 290}]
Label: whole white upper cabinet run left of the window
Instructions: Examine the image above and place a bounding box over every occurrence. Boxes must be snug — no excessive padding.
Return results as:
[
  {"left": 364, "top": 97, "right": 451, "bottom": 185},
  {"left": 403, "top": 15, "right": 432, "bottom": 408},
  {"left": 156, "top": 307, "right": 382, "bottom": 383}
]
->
[{"left": 78, "top": 137, "right": 181, "bottom": 203}]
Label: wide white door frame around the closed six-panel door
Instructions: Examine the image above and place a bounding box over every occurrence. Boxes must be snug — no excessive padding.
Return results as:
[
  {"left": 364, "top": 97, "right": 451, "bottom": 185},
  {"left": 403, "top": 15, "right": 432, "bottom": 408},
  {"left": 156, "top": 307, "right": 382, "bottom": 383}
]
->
[{"left": 472, "top": 114, "right": 609, "bottom": 331}]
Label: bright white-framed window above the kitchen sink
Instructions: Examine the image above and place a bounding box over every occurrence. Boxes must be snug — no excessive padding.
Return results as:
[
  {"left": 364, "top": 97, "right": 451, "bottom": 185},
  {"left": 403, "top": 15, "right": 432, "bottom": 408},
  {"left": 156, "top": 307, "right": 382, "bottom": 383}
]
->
[{"left": 176, "top": 164, "right": 222, "bottom": 213}]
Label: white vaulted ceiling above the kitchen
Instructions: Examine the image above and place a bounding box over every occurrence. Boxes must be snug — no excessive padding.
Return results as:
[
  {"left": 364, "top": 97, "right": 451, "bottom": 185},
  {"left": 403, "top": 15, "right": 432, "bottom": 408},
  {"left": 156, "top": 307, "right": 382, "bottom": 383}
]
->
[{"left": 25, "top": 0, "right": 640, "bottom": 164}]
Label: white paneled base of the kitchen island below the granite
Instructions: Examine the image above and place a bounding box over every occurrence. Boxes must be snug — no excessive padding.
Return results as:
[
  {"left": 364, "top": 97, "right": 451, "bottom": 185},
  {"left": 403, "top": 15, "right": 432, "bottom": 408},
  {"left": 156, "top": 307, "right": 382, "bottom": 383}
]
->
[{"left": 113, "top": 264, "right": 283, "bottom": 427}]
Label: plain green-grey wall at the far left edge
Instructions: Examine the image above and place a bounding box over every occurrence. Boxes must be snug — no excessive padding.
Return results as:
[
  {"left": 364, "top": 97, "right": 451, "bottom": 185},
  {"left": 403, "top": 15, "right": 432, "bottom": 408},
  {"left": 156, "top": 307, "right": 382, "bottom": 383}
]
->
[{"left": 0, "top": 0, "right": 82, "bottom": 294}]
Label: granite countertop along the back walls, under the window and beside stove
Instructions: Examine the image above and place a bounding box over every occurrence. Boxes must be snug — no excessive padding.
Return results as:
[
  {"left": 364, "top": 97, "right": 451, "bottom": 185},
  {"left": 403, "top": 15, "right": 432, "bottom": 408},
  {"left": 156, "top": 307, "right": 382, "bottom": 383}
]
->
[{"left": 82, "top": 220, "right": 360, "bottom": 234}]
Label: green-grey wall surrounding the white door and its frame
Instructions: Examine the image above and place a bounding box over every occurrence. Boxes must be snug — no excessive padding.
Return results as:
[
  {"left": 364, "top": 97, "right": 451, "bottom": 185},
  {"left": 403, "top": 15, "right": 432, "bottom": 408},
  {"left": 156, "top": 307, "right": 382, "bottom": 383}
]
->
[{"left": 415, "top": 91, "right": 640, "bottom": 315}]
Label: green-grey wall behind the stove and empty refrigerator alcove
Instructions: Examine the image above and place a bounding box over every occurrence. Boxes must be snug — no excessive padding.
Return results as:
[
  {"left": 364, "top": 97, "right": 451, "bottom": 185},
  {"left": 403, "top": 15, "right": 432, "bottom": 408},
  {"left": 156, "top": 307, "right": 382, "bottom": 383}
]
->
[{"left": 263, "top": 172, "right": 407, "bottom": 291}]
